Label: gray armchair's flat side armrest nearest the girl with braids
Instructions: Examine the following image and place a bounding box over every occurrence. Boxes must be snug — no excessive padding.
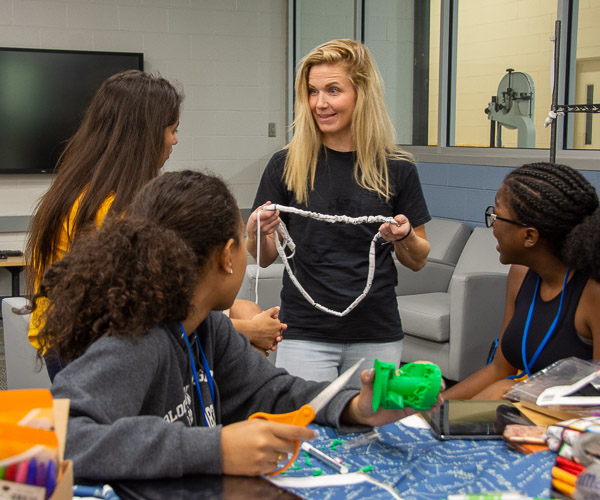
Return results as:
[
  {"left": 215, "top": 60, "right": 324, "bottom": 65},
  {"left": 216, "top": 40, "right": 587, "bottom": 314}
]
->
[{"left": 446, "top": 273, "right": 507, "bottom": 381}]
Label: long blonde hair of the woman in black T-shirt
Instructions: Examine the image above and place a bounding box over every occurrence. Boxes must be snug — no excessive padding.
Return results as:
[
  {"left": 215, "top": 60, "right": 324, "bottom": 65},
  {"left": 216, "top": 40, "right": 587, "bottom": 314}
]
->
[{"left": 283, "top": 39, "right": 413, "bottom": 203}]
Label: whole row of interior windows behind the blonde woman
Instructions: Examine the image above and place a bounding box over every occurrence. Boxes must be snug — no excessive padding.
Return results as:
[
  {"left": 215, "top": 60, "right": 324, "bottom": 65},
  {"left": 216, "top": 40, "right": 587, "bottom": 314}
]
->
[{"left": 289, "top": 0, "right": 600, "bottom": 161}]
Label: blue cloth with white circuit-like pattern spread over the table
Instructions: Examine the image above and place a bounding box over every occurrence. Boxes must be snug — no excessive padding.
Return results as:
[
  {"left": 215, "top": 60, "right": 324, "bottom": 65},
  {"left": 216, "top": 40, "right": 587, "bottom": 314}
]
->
[{"left": 276, "top": 422, "right": 556, "bottom": 500}]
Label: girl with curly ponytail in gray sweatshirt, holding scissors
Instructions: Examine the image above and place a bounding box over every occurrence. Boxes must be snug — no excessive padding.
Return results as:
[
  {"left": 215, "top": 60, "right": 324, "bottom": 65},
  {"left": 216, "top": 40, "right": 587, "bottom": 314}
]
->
[{"left": 42, "top": 171, "right": 432, "bottom": 481}]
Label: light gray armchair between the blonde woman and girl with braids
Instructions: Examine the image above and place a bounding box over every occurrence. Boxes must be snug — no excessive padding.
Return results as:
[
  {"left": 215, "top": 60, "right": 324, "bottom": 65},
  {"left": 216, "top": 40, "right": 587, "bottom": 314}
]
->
[{"left": 397, "top": 227, "right": 509, "bottom": 381}]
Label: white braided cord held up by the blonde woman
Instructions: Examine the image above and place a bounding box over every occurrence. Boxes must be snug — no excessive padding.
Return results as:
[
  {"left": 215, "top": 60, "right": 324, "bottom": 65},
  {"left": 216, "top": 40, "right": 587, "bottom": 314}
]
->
[{"left": 254, "top": 205, "right": 398, "bottom": 317}]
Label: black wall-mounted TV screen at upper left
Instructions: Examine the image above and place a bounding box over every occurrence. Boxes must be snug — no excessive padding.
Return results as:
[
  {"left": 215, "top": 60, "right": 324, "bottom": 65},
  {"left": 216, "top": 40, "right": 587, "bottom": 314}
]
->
[{"left": 0, "top": 47, "right": 144, "bottom": 174}]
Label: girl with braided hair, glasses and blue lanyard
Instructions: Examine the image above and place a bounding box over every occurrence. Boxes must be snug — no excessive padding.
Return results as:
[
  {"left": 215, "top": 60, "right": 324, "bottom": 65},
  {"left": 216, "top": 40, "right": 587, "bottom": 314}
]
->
[{"left": 444, "top": 163, "right": 600, "bottom": 399}]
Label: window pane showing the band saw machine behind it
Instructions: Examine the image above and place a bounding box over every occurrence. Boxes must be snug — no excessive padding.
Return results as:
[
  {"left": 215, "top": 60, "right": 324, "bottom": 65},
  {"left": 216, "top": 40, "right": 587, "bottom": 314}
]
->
[{"left": 450, "top": 0, "right": 556, "bottom": 148}]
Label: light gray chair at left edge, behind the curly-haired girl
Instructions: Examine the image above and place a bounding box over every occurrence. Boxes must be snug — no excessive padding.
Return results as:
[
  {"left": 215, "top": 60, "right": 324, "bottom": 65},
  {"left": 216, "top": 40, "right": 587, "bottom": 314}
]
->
[{"left": 2, "top": 297, "right": 51, "bottom": 389}]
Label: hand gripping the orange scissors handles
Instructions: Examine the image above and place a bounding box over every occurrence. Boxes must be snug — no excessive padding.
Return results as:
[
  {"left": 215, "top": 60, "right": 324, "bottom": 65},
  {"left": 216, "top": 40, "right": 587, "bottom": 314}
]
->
[{"left": 221, "top": 418, "right": 315, "bottom": 476}]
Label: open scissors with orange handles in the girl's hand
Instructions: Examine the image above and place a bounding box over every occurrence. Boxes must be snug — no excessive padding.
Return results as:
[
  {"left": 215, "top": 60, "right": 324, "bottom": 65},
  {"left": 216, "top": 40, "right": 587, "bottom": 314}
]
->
[{"left": 248, "top": 358, "right": 365, "bottom": 476}]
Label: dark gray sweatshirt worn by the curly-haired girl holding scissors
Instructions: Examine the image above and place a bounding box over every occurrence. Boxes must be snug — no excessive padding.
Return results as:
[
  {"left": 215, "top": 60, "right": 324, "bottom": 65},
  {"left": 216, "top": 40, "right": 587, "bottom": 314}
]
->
[{"left": 52, "top": 312, "right": 364, "bottom": 481}]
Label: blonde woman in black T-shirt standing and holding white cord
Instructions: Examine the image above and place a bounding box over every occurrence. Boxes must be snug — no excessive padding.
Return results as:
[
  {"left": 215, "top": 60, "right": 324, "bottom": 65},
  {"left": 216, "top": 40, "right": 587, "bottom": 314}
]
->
[{"left": 247, "top": 40, "right": 430, "bottom": 381}]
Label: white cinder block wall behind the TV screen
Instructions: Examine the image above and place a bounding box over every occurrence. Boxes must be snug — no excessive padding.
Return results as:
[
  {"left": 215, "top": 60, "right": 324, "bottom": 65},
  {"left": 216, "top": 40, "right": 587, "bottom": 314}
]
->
[{"left": 0, "top": 0, "right": 287, "bottom": 295}]
